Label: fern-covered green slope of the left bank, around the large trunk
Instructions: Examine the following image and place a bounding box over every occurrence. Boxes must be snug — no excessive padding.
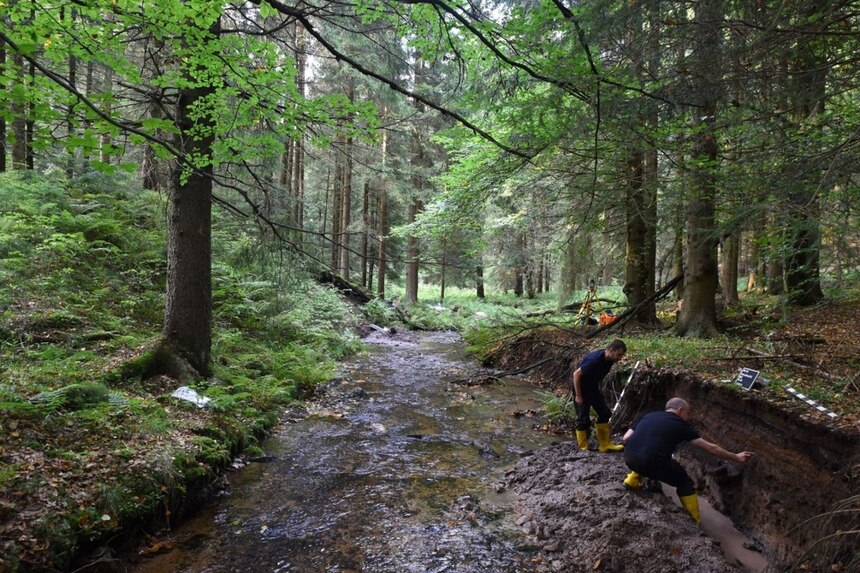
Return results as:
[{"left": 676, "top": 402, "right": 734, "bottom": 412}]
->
[{"left": 0, "top": 172, "right": 362, "bottom": 571}]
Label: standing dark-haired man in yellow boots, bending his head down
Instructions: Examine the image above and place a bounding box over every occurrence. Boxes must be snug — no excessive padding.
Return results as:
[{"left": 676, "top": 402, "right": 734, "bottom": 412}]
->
[{"left": 573, "top": 339, "right": 627, "bottom": 453}]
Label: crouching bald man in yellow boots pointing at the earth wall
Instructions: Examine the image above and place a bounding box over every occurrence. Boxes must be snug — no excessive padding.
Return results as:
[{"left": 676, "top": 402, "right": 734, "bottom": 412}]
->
[{"left": 622, "top": 398, "right": 753, "bottom": 523}]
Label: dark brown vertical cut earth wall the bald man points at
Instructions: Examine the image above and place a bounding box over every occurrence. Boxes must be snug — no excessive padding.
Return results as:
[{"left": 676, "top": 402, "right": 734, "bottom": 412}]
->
[{"left": 613, "top": 370, "right": 860, "bottom": 570}]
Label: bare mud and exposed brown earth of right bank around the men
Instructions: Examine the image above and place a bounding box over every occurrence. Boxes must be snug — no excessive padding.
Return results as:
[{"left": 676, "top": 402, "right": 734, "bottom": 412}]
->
[{"left": 494, "top": 333, "right": 860, "bottom": 572}]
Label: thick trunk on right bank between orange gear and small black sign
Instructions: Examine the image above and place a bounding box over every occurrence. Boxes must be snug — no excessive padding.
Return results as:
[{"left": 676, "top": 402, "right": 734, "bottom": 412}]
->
[{"left": 677, "top": 0, "right": 721, "bottom": 338}]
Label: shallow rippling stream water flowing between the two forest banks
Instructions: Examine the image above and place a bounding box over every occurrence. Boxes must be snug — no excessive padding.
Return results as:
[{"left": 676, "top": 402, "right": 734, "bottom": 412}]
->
[{"left": 134, "top": 333, "right": 551, "bottom": 573}]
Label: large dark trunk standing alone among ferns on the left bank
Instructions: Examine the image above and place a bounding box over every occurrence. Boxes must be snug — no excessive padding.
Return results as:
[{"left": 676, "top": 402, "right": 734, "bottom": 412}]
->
[{"left": 162, "top": 20, "right": 220, "bottom": 376}]
